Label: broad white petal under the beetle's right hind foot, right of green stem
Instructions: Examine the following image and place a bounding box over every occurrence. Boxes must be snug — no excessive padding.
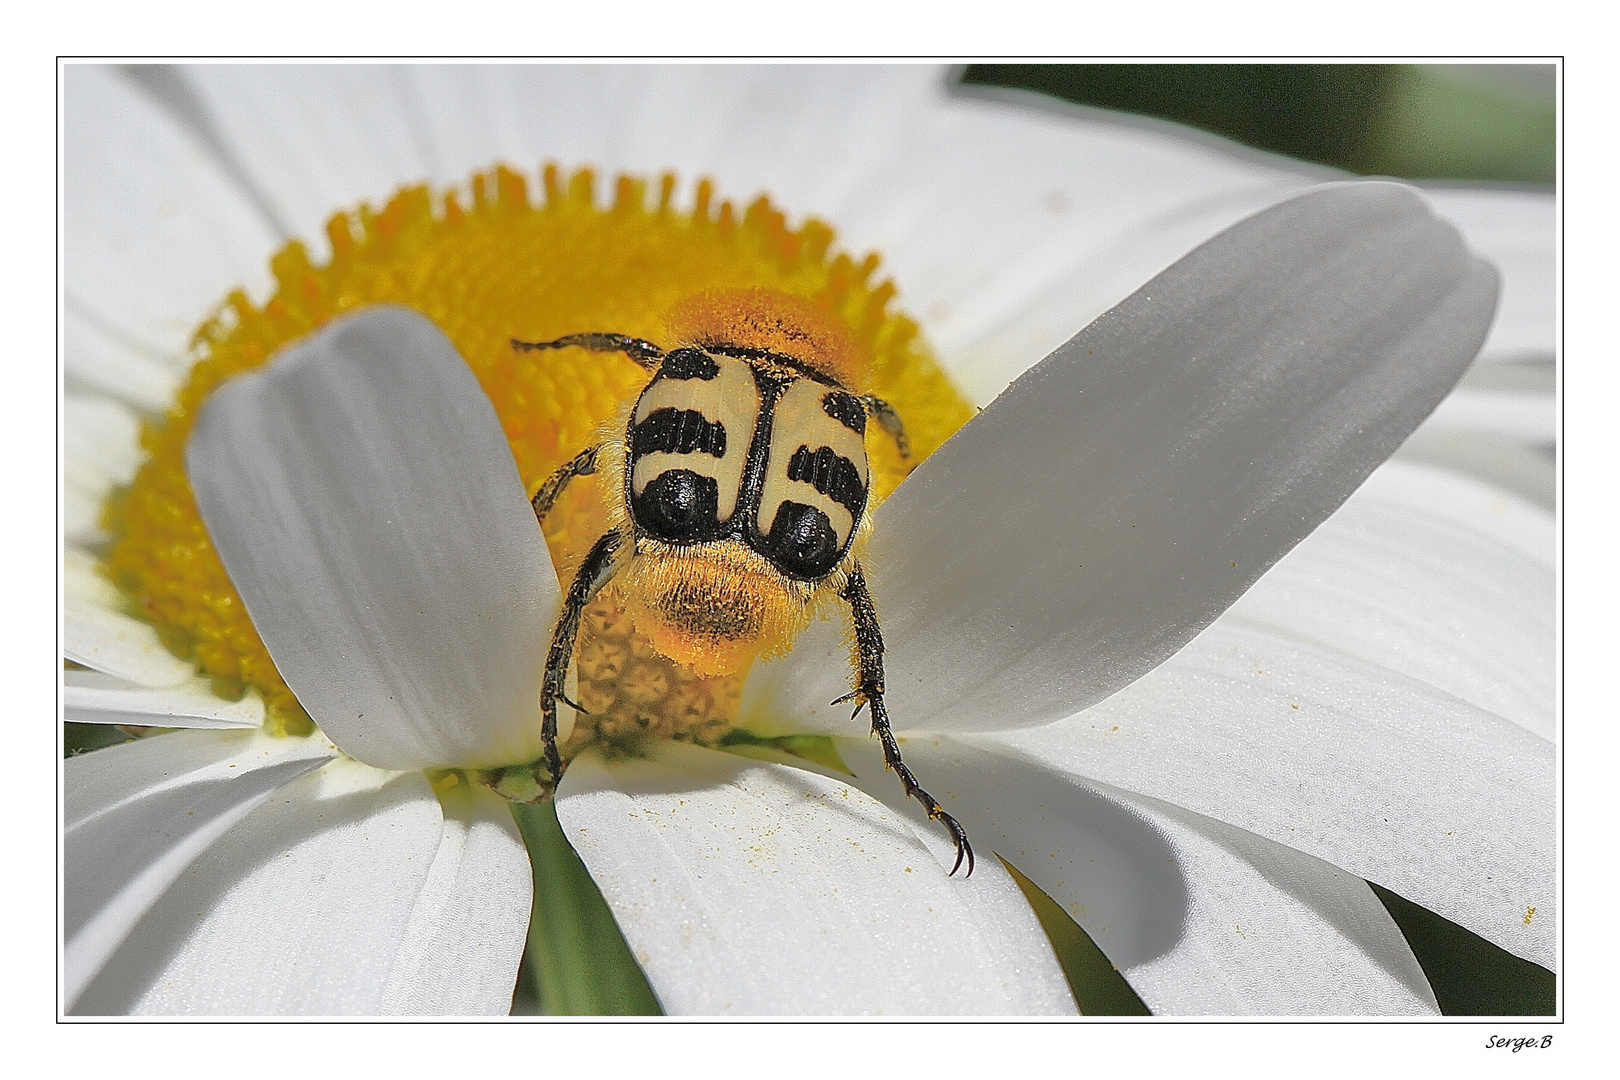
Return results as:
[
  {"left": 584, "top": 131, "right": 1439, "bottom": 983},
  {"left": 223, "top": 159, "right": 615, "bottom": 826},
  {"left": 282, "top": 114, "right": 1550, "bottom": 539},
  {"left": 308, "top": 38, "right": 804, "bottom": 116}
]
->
[{"left": 557, "top": 743, "right": 1074, "bottom": 1015}]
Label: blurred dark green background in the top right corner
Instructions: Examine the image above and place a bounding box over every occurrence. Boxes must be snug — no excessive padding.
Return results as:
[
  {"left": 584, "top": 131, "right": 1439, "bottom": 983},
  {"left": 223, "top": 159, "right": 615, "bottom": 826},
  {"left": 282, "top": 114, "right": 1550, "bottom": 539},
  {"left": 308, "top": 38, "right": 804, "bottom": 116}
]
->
[{"left": 962, "top": 63, "right": 1557, "bottom": 186}]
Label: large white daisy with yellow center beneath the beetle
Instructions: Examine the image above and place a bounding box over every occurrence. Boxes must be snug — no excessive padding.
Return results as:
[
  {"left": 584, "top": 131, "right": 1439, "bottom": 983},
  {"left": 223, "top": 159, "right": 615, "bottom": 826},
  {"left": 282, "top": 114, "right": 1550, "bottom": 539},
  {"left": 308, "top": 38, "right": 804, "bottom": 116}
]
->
[{"left": 63, "top": 66, "right": 1555, "bottom": 1015}]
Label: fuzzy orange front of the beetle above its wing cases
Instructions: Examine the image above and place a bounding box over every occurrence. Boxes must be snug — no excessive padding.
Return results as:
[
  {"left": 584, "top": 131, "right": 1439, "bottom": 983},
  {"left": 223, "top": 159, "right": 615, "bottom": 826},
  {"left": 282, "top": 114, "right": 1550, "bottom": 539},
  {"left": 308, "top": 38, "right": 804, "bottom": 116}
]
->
[{"left": 664, "top": 288, "right": 872, "bottom": 393}]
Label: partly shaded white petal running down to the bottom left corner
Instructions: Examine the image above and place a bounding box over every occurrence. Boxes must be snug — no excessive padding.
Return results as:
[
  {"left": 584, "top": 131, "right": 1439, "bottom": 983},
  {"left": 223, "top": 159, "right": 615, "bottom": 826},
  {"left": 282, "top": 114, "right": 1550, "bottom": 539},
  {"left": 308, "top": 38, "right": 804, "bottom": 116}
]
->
[{"left": 62, "top": 732, "right": 334, "bottom": 1007}]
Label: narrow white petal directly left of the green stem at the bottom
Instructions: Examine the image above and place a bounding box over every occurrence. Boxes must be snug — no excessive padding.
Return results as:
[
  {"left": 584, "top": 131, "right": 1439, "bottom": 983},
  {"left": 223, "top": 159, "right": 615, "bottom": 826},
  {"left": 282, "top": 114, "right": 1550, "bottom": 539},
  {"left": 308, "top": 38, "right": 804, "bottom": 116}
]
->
[{"left": 377, "top": 784, "right": 535, "bottom": 1017}]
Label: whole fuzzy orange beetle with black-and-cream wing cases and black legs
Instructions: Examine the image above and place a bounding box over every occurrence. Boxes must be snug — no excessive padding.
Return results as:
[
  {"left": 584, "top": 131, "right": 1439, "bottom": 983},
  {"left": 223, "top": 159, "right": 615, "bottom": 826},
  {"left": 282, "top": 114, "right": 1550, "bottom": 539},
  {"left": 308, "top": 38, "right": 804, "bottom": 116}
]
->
[{"left": 512, "top": 288, "right": 974, "bottom": 874}]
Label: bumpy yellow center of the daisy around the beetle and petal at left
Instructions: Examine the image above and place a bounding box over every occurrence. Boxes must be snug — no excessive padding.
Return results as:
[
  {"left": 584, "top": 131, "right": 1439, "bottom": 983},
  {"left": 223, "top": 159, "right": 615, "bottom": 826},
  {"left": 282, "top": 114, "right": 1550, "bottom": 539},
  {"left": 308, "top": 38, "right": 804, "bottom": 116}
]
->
[{"left": 105, "top": 167, "right": 974, "bottom": 764}]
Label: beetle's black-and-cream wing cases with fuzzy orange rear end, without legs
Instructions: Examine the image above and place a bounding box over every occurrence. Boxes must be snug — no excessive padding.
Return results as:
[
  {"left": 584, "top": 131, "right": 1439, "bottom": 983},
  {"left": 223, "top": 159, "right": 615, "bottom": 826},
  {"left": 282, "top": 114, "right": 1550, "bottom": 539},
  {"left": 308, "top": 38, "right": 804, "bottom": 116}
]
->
[{"left": 599, "top": 345, "right": 870, "bottom": 675}]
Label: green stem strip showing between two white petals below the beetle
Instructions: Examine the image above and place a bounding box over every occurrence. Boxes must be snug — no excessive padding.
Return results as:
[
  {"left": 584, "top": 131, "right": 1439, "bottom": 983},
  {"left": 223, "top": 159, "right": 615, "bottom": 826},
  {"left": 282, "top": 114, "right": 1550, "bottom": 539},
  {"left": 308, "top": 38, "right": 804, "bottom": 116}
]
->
[{"left": 512, "top": 800, "right": 663, "bottom": 1017}]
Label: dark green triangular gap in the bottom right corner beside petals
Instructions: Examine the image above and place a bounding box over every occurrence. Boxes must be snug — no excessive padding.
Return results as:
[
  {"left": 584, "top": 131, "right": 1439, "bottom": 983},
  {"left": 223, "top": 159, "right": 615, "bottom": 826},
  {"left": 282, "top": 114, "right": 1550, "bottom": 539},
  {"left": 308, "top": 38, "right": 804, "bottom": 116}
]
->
[{"left": 1367, "top": 881, "right": 1558, "bottom": 1017}]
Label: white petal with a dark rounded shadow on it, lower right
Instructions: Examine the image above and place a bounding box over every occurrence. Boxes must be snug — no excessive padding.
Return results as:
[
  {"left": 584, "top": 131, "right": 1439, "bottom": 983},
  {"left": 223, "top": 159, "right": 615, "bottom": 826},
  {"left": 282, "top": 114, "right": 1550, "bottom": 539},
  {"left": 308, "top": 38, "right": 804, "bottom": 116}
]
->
[{"left": 838, "top": 737, "right": 1437, "bottom": 1015}]
